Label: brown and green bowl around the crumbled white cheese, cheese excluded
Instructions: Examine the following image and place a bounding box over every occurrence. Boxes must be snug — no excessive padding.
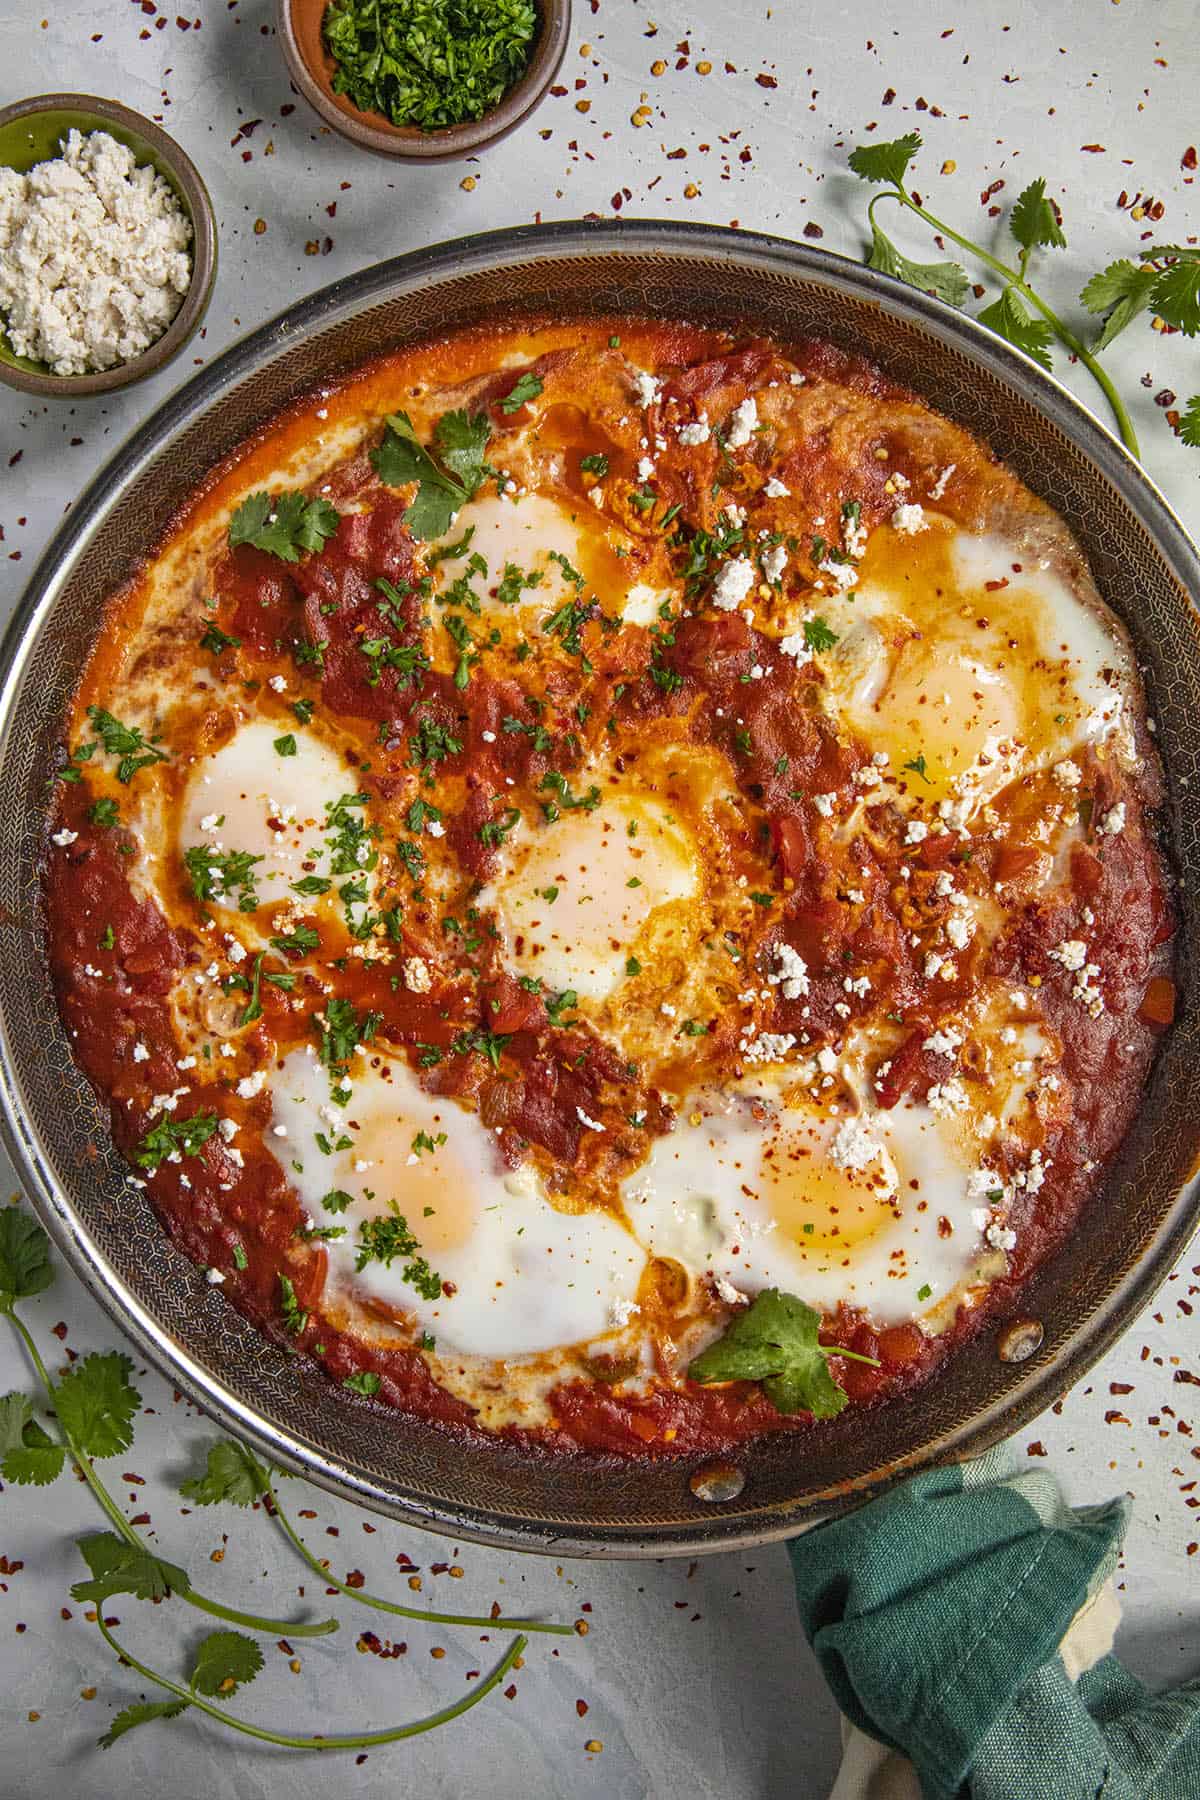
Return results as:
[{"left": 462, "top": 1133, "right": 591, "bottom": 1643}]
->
[{"left": 0, "top": 94, "right": 216, "bottom": 400}]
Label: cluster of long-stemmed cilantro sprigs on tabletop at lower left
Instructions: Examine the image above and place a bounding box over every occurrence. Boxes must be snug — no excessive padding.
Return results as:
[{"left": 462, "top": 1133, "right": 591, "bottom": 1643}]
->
[{"left": 0, "top": 1206, "right": 572, "bottom": 1751}]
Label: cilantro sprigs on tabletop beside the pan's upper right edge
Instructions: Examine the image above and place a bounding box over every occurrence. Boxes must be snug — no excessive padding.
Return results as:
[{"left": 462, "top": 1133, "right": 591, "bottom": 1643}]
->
[{"left": 849, "top": 131, "right": 1200, "bottom": 455}]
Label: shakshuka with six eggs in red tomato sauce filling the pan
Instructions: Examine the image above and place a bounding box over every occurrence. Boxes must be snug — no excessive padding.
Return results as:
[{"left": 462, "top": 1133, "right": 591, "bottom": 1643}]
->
[{"left": 45, "top": 317, "right": 1175, "bottom": 1458}]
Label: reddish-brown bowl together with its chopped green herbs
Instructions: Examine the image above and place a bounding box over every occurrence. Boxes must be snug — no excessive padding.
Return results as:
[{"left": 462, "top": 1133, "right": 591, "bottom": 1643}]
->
[{"left": 275, "top": 0, "right": 570, "bottom": 162}]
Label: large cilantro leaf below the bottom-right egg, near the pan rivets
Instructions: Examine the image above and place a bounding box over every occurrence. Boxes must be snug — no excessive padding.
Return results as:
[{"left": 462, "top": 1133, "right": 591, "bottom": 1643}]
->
[{"left": 687, "top": 1287, "right": 846, "bottom": 1418}]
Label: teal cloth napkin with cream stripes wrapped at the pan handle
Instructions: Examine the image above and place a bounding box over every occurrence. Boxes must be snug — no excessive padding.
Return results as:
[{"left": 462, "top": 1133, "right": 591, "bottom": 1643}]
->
[{"left": 788, "top": 1451, "right": 1200, "bottom": 1800}]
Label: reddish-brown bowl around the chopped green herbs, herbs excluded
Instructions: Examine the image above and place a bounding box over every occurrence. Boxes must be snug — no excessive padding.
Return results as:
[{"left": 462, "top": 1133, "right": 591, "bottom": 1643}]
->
[{"left": 275, "top": 0, "right": 570, "bottom": 162}]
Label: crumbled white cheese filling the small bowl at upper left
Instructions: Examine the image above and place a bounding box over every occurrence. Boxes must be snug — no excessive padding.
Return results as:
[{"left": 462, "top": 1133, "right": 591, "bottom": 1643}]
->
[{"left": 0, "top": 130, "right": 193, "bottom": 374}]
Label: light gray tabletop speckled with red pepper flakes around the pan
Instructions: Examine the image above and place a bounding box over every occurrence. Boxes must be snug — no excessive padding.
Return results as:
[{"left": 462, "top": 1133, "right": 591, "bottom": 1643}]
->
[{"left": 0, "top": 0, "right": 1200, "bottom": 1800}]
